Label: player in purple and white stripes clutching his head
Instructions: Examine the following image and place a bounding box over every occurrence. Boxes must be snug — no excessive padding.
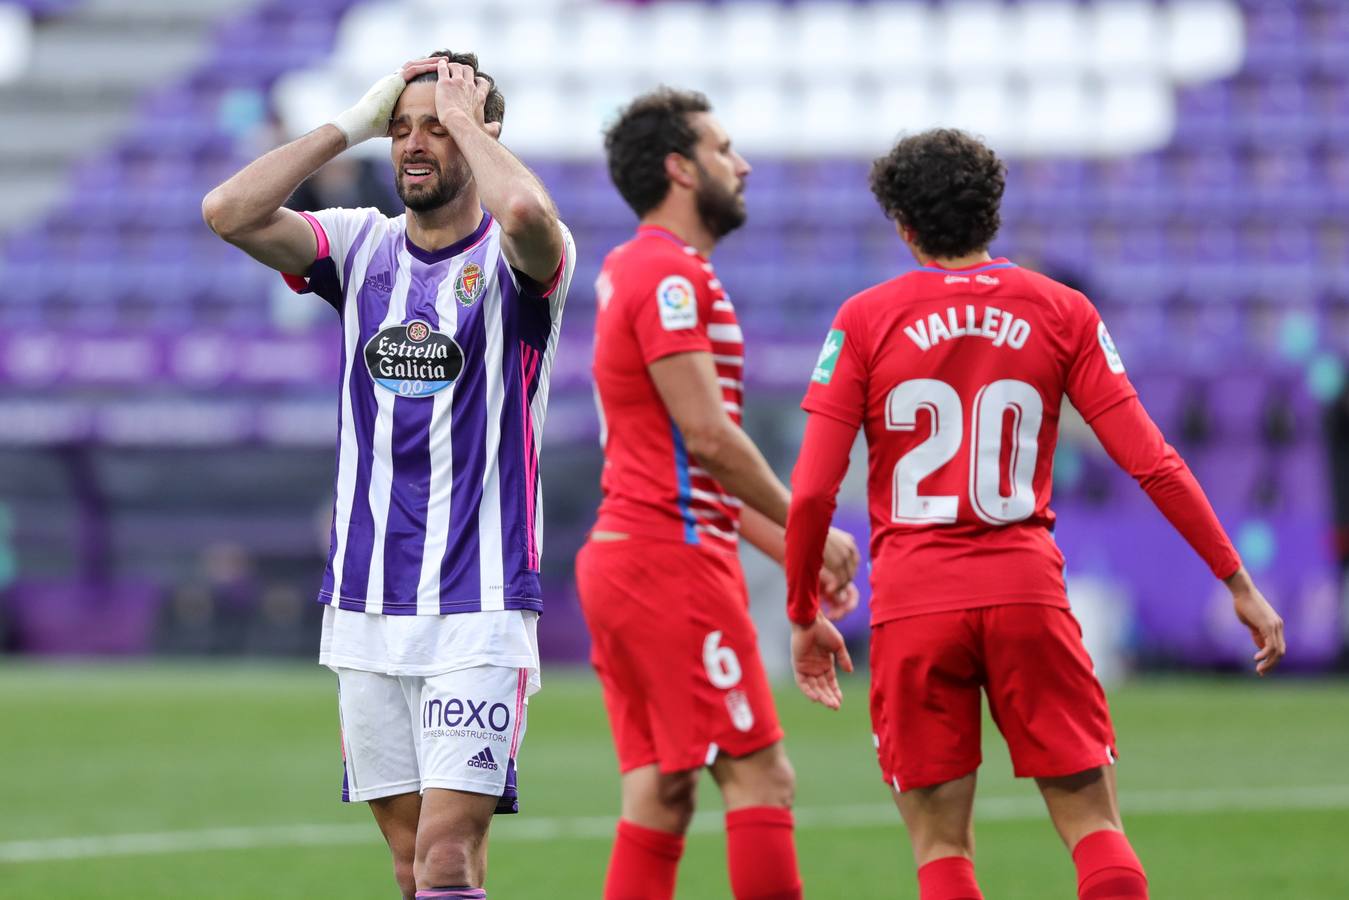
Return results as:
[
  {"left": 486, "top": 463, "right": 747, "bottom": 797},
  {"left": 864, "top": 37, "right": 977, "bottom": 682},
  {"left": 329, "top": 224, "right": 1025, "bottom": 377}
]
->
[{"left": 202, "top": 51, "right": 575, "bottom": 897}]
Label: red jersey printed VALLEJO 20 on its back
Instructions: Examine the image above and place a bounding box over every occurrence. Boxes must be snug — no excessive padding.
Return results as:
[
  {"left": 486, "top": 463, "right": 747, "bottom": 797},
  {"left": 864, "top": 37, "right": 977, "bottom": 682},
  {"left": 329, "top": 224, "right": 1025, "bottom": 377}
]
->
[{"left": 803, "top": 259, "right": 1136, "bottom": 623}]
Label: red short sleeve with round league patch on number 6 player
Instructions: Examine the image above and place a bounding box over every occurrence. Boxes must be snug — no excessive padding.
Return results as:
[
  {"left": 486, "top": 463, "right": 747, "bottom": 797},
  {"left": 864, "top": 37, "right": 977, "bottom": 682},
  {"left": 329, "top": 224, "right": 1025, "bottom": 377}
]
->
[{"left": 623, "top": 259, "right": 712, "bottom": 366}]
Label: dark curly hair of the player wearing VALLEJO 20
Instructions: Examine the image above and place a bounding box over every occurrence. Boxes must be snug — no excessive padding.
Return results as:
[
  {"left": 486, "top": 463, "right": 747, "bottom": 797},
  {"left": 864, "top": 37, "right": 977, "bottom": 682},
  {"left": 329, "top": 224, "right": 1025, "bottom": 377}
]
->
[{"left": 871, "top": 128, "right": 1006, "bottom": 258}]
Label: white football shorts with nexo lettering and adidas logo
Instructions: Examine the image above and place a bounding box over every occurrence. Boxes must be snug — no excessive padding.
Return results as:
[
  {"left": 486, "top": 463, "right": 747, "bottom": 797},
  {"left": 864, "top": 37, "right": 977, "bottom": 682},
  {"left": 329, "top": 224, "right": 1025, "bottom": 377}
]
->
[{"left": 335, "top": 665, "right": 529, "bottom": 814}]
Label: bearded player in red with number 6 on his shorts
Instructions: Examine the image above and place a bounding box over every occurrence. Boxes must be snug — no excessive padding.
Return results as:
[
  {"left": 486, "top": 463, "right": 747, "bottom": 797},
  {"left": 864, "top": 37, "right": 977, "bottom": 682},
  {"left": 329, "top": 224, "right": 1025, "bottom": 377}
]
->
[{"left": 576, "top": 89, "right": 858, "bottom": 900}]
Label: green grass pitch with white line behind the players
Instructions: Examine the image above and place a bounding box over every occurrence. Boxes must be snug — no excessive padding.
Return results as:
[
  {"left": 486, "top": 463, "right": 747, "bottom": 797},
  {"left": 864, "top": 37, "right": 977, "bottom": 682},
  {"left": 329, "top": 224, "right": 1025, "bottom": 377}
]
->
[{"left": 0, "top": 664, "right": 1349, "bottom": 900}]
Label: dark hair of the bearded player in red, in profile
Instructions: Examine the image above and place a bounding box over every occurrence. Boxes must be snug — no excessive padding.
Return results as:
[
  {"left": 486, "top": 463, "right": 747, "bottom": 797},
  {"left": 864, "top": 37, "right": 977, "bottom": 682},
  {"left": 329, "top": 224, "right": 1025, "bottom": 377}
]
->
[{"left": 604, "top": 86, "right": 712, "bottom": 216}]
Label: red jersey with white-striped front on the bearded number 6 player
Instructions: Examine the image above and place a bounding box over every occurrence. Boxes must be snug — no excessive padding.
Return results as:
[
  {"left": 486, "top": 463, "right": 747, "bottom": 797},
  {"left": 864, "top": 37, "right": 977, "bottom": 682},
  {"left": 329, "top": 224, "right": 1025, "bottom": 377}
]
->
[{"left": 594, "top": 225, "right": 745, "bottom": 551}]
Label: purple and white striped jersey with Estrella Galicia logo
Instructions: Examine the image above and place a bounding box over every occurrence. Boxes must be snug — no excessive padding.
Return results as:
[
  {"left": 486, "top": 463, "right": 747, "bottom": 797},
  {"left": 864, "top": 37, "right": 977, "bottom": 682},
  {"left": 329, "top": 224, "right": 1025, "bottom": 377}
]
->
[{"left": 286, "top": 209, "right": 576, "bottom": 615}]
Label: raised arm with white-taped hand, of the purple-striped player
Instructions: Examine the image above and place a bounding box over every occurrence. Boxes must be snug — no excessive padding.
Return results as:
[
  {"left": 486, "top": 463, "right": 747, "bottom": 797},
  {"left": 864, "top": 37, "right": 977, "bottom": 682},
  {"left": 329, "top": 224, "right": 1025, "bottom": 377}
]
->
[{"left": 201, "top": 73, "right": 406, "bottom": 274}]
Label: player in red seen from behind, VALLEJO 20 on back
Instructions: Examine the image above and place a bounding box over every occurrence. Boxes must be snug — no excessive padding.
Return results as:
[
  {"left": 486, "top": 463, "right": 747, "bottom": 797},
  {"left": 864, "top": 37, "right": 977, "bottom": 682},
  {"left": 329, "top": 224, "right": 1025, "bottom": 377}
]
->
[{"left": 786, "top": 131, "right": 1284, "bottom": 900}]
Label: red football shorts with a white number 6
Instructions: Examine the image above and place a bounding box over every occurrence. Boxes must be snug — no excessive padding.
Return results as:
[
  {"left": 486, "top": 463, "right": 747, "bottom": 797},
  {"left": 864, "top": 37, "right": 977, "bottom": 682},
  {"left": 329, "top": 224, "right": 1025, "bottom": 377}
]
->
[{"left": 576, "top": 538, "right": 782, "bottom": 772}]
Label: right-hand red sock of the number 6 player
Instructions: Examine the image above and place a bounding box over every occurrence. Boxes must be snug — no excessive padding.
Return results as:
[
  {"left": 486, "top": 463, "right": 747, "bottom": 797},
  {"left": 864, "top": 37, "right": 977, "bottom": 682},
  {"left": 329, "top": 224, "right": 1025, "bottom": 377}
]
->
[{"left": 726, "top": 807, "right": 801, "bottom": 900}]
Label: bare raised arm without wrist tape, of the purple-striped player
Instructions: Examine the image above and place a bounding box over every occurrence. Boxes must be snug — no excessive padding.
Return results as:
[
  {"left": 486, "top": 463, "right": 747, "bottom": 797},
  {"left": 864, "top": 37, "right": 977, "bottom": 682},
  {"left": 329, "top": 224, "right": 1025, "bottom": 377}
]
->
[{"left": 426, "top": 59, "right": 564, "bottom": 285}]
